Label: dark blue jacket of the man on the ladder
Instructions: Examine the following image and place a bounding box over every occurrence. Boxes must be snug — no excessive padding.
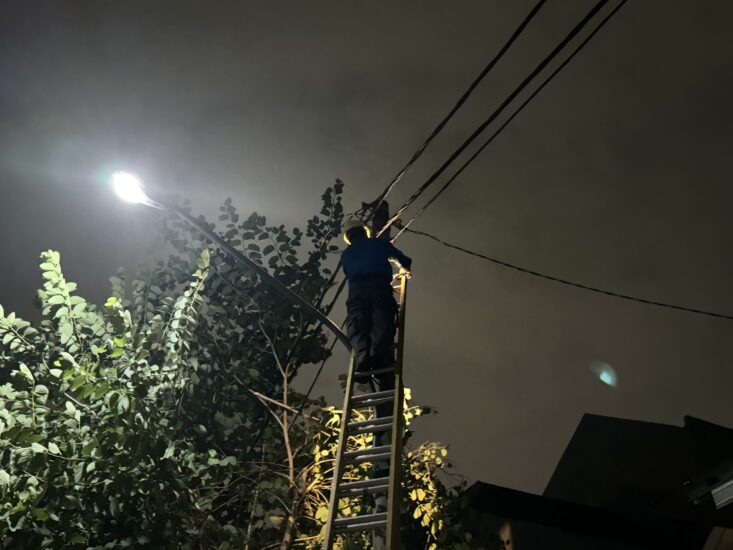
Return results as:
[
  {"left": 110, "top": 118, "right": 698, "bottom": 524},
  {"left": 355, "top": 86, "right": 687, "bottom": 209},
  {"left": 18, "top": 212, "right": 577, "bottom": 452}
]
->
[{"left": 341, "top": 239, "right": 412, "bottom": 288}]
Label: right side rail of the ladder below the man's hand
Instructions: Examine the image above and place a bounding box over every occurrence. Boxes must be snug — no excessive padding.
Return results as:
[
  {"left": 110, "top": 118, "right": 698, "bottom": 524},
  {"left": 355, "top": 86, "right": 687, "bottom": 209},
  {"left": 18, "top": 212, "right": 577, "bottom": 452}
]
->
[{"left": 386, "top": 275, "right": 407, "bottom": 550}]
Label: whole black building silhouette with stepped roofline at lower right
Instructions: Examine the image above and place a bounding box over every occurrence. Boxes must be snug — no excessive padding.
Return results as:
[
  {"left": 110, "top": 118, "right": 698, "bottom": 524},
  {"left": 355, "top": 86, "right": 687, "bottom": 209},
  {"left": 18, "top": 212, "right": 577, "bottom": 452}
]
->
[{"left": 466, "top": 414, "right": 733, "bottom": 550}]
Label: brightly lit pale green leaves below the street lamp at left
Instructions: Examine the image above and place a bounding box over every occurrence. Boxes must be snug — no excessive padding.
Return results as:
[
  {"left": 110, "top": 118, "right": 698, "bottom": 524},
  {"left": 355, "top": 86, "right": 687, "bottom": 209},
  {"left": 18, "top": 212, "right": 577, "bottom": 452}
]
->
[{"left": 0, "top": 251, "right": 236, "bottom": 547}]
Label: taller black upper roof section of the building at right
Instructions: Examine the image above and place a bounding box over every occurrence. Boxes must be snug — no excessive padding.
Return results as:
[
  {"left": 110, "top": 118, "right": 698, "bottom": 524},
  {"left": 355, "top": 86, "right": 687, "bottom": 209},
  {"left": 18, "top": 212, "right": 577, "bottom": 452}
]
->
[{"left": 544, "top": 414, "right": 733, "bottom": 528}]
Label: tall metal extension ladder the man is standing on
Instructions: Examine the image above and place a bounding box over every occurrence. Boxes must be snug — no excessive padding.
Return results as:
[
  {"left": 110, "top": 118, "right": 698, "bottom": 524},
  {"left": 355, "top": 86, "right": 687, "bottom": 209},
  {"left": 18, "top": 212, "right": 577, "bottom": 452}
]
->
[{"left": 323, "top": 274, "right": 407, "bottom": 550}]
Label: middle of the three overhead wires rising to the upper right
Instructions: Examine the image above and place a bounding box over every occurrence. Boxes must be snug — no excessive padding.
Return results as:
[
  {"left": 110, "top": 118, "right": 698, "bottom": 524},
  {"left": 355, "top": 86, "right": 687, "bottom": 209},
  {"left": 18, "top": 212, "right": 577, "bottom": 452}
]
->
[{"left": 378, "top": 0, "right": 608, "bottom": 235}]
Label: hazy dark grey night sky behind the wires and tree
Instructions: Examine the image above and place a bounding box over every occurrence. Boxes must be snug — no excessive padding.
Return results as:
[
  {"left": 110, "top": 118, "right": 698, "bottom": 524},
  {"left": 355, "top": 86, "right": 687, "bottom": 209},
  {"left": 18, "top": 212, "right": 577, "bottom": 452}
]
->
[{"left": 0, "top": 0, "right": 733, "bottom": 492}]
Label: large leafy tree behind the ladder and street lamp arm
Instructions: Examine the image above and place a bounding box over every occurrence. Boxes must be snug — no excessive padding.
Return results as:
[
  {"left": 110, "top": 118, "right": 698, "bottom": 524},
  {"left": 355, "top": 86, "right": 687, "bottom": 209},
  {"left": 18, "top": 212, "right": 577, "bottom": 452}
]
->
[{"left": 0, "top": 183, "right": 472, "bottom": 550}]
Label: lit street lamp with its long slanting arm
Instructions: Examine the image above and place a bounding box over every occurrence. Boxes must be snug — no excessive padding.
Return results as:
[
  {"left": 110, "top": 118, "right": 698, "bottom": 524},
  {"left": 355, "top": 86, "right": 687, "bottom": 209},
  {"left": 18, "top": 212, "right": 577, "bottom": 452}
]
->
[{"left": 112, "top": 172, "right": 351, "bottom": 351}]
